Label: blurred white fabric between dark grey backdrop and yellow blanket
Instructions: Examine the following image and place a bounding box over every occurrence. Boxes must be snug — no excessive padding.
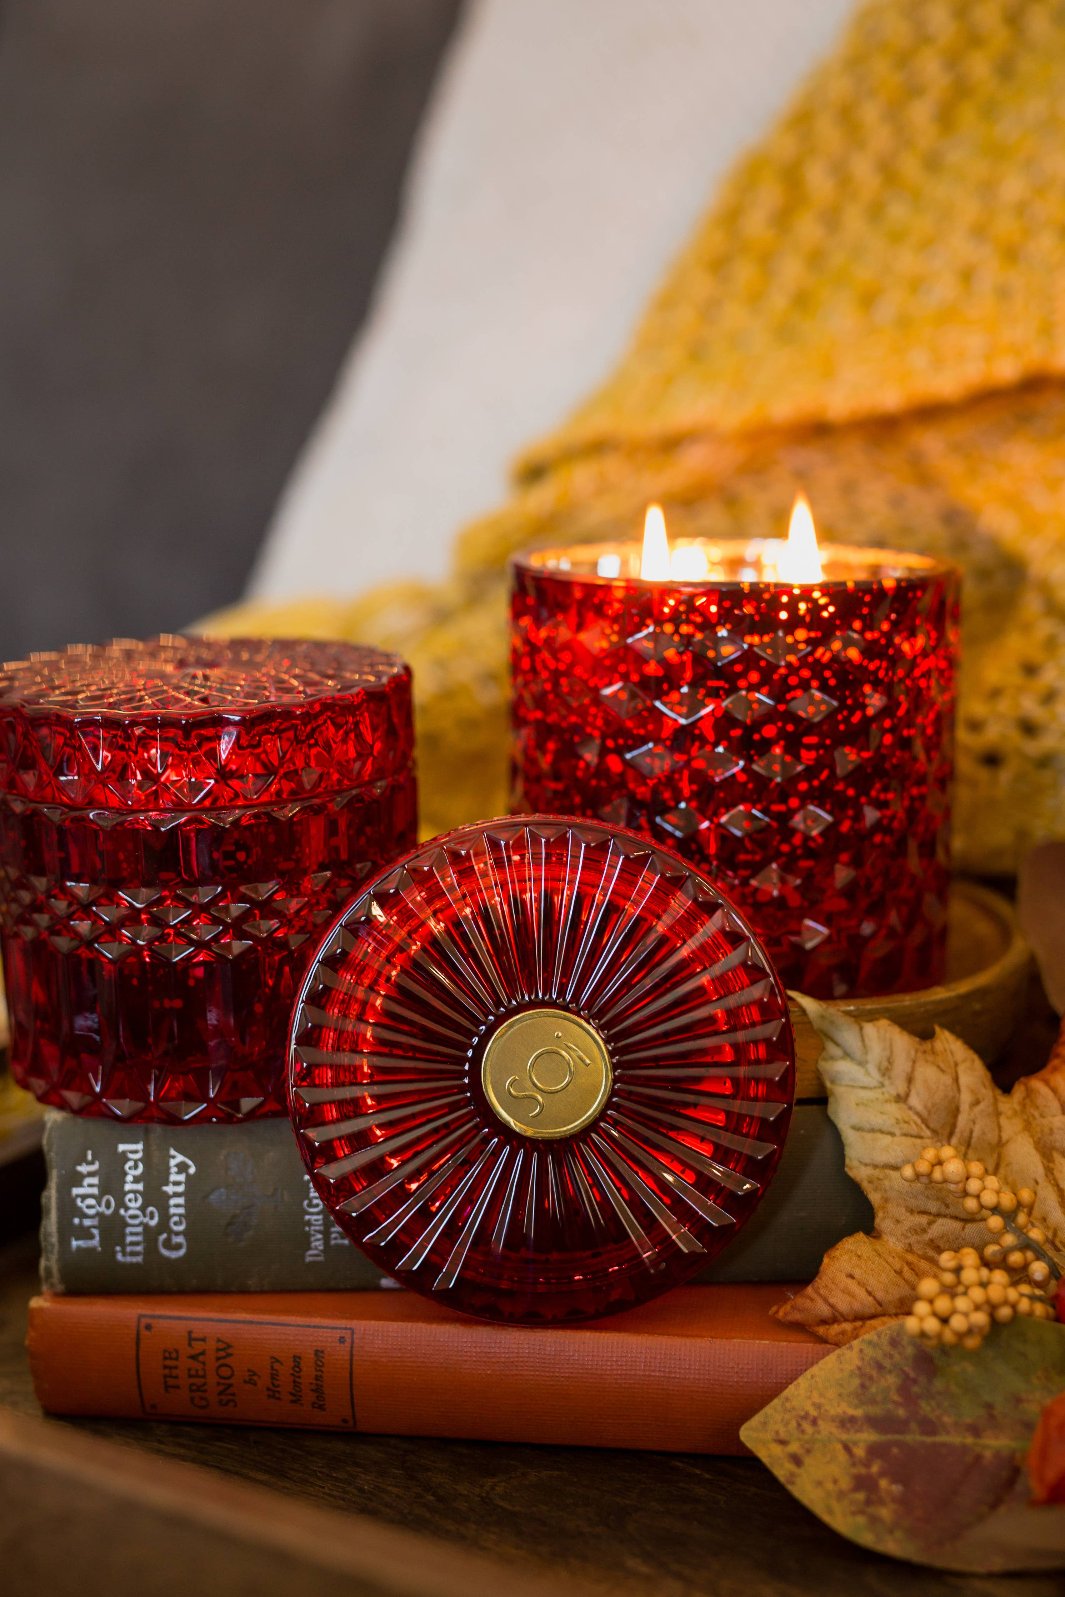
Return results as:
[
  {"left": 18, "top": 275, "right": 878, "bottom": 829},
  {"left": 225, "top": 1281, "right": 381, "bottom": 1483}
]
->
[{"left": 252, "top": 0, "right": 854, "bottom": 597}]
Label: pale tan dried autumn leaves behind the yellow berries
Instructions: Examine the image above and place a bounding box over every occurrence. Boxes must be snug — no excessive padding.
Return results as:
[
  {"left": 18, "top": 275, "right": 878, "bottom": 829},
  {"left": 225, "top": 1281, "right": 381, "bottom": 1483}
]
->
[{"left": 776, "top": 997, "right": 1065, "bottom": 1345}]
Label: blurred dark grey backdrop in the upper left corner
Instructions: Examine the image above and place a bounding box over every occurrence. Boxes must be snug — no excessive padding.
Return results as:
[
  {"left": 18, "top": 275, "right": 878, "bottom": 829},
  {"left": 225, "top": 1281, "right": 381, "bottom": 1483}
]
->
[{"left": 0, "top": 0, "right": 458, "bottom": 660}]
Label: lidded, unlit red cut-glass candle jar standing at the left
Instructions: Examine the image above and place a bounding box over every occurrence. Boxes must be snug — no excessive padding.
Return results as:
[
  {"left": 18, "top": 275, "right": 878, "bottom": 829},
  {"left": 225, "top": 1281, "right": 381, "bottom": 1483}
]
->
[{"left": 0, "top": 637, "right": 417, "bottom": 1121}]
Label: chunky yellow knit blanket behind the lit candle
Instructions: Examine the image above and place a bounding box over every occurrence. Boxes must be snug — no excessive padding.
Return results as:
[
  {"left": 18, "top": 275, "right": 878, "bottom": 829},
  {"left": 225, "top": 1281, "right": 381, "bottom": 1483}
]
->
[{"left": 212, "top": 0, "right": 1065, "bottom": 870}]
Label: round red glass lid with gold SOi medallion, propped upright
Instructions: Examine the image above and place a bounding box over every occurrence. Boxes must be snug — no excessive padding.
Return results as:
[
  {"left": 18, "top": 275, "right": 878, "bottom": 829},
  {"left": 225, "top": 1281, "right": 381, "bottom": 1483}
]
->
[{"left": 289, "top": 818, "right": 794, "bottom": 1324}]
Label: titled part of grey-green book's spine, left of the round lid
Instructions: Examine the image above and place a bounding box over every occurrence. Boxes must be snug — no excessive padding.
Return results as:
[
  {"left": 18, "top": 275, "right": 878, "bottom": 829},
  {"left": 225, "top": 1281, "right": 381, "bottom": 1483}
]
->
[{"left": 42, "top": 1112, "right": 382, "bottom": 1292}]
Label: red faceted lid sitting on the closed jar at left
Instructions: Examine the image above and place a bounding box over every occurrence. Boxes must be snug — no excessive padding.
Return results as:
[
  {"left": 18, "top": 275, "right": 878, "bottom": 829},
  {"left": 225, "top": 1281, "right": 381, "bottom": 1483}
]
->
[{"left": 0, "top": 637, "right": 414, "bottom": 811}]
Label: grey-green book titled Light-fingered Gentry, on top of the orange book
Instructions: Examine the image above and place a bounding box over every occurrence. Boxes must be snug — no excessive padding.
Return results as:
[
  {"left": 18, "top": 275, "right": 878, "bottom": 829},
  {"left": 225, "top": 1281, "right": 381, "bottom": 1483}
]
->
[{"left": 42, "top": 1104, "right": 872, "bottom": 1294}]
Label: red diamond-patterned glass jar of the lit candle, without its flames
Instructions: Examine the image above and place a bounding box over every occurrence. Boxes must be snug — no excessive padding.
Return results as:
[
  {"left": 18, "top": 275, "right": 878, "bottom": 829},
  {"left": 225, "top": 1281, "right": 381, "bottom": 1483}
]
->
[{"left": 511, "top": 546, "right": 958, "bottom": 998}]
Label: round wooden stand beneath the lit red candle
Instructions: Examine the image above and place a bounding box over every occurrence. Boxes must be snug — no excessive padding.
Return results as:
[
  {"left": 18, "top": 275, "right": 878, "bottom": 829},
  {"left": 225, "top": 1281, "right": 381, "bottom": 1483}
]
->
[{"left": 792, "top": 882, "right": 1031, "bottom": 1099}]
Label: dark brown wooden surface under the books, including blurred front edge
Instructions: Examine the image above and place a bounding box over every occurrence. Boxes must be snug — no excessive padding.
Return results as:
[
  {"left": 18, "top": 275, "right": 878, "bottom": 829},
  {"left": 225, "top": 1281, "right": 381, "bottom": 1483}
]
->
[{"left": 0, "top": 1207, "right": 1062, "bottom": 1597}]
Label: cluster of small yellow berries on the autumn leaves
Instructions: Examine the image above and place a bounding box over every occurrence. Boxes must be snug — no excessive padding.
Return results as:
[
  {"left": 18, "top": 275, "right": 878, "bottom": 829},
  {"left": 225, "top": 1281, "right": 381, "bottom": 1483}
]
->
[{"left": 901, "top": 1145, "right": 1055, "bottom": 1348}]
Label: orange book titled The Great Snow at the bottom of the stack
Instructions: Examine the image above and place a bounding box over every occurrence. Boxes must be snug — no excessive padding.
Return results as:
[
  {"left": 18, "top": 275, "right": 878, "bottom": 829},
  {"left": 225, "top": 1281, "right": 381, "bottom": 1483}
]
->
[{"left": 29, "top": 1286, "right": 830, "bottom": 1453}]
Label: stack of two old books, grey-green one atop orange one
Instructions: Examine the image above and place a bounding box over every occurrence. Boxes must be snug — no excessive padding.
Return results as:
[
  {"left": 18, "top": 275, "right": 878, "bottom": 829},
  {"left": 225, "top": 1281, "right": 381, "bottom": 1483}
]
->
[{"left": 29, "top": 1102, "right": 870, "bottom": 1452}]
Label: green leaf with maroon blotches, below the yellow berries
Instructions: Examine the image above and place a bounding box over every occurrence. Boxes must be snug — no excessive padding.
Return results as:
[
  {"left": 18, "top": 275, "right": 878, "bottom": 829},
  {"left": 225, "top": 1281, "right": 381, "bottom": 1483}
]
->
[{"left": 741, "top": 1319, "right": 1065, "bottom": 1573}]
